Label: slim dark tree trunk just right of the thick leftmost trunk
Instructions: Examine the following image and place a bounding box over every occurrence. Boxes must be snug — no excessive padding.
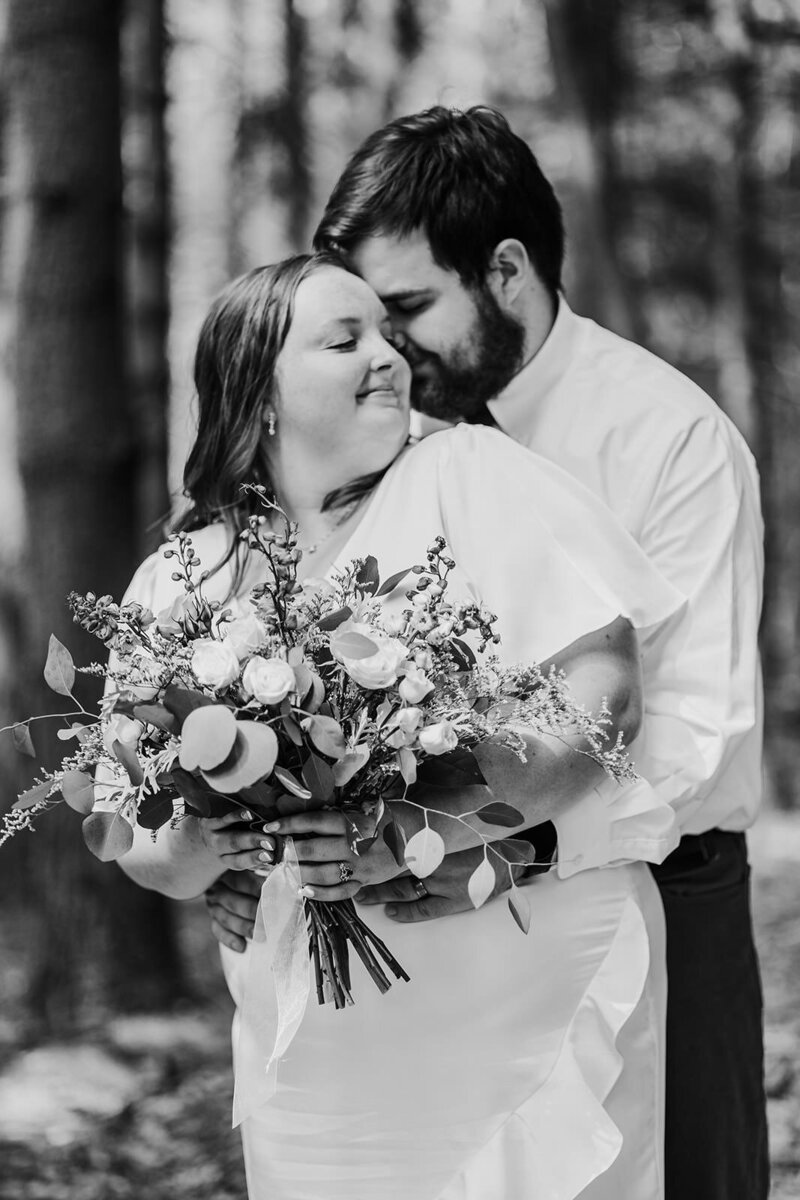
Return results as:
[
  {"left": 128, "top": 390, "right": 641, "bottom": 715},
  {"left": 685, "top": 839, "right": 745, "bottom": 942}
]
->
[{"left": 122, "top": 0, "right": 170, "bottom": 557}]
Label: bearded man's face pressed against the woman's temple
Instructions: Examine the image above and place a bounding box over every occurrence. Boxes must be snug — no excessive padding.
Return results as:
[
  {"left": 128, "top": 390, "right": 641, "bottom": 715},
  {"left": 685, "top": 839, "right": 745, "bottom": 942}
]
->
[{"left": 350, "top": 233, "right": 525, "bottom": 421}]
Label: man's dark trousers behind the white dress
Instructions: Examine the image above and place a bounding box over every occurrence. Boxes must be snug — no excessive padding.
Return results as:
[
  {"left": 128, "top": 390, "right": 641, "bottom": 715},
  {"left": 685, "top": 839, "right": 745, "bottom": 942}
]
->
[{"left": 652, "top": 829, "right": 769, "bottom": 1200}]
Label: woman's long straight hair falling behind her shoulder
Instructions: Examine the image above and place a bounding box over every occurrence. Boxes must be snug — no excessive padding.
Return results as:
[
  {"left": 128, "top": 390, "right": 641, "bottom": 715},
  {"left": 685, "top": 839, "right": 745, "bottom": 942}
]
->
[{"left": 173, "top": 251, "right": 383, "bottom": 595}]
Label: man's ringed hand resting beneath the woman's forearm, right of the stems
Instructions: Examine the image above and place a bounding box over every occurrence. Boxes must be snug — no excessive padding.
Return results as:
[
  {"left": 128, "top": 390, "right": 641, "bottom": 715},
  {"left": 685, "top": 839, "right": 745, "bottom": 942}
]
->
[{"left": 356, "top": 844, "right": 524, "bottom": 922}]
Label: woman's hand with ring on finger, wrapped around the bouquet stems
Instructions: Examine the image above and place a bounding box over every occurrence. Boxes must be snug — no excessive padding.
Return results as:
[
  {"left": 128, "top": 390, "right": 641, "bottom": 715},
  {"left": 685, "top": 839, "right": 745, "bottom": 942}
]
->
[{"left": 264, "top": 809, "right": 403, "bottom": 900}]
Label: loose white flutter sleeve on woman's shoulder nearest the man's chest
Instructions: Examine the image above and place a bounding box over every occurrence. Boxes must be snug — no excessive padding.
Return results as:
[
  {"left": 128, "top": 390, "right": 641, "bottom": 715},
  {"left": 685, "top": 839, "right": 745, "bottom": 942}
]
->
[{"left": 434, "top": 425, "right": 685, "bottom": 662}]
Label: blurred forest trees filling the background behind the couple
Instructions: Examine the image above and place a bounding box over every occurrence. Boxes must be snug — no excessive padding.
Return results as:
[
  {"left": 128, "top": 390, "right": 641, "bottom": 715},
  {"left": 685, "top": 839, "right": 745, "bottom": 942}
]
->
[{"left": 0, "top": 0, "right": 800, "bottom": 1030}]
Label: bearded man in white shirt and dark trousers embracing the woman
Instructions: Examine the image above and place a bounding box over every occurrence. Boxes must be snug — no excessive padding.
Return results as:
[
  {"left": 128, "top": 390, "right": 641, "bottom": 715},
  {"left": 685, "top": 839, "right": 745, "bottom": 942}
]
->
[{"left": 210, "top": 107, "right": 768, "bottom": 1200}]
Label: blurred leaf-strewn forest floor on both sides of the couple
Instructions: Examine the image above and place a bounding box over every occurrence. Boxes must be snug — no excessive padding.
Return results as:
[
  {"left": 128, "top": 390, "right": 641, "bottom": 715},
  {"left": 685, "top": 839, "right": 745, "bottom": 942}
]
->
[{"left": 0, "top": 814, "right": 800, "bottom": 1200}]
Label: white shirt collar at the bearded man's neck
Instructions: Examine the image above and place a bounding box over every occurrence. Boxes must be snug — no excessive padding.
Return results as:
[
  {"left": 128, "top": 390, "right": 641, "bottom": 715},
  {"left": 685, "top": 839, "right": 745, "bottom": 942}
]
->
[{"left": 488, "top": 296, "right": 582, "bottom": 438}]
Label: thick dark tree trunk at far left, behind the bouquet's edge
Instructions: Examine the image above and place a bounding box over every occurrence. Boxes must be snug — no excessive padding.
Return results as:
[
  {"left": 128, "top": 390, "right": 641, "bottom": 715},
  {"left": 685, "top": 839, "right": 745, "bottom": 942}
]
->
[{"left": 7, "top": 0, "right": 183, "bottom": 1033}]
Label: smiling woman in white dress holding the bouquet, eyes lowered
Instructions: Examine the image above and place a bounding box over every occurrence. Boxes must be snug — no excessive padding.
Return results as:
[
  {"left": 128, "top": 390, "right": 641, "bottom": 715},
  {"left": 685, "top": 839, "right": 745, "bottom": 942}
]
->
[{"left": 121, "top": 254, "right": 680, "bottom": 1200}]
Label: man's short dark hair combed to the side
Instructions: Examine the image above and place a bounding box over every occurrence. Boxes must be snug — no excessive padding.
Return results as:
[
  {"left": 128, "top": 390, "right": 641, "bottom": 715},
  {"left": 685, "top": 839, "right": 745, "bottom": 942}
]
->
[{"left": 314, "top": 104, "right": 564, "bottom": 295}]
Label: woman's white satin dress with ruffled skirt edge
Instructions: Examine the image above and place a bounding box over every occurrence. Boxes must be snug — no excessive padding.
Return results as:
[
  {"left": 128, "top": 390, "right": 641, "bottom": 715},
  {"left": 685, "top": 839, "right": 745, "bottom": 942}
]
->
[{"left": 128, "top": 426, "right": 681, "bottom": 1200}]
